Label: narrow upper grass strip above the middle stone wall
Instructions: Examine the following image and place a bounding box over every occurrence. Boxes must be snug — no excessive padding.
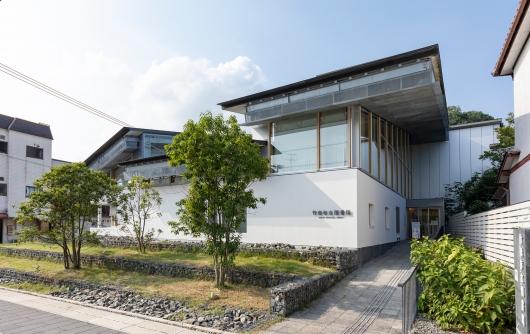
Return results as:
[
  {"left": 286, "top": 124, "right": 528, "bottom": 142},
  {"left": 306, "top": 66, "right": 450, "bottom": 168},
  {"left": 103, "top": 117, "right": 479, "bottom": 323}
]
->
[{"left": 0, "top": 243, "right": 334, "bottom": 277}]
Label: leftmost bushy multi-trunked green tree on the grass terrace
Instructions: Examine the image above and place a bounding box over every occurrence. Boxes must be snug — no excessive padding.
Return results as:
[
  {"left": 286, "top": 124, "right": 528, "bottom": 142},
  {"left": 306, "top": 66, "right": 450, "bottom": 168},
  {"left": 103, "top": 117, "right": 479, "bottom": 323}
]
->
[{"left": 16, "top": 162, "right": 118, "bottom": 269}]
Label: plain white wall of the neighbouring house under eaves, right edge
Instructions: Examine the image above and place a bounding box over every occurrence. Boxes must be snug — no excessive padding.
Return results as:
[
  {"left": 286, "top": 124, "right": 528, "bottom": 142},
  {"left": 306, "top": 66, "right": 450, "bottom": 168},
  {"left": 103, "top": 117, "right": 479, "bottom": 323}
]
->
[{"left": 510, "top": 36, "right": 530, "bottom": 204}]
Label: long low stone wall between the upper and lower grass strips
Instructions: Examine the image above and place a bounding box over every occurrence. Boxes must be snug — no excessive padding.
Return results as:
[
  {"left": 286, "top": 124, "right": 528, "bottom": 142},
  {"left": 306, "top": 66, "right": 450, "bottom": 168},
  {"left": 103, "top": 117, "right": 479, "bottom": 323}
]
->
[{"left": 0, "top": 247, "right": 294, "bottom": 287}]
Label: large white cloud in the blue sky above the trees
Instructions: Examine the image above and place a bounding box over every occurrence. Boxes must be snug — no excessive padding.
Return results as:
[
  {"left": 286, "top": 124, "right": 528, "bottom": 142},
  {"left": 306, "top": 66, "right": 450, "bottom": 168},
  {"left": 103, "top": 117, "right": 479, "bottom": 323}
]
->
[{"left": 131, "top": 56, "right": 266, "bottom": 131}]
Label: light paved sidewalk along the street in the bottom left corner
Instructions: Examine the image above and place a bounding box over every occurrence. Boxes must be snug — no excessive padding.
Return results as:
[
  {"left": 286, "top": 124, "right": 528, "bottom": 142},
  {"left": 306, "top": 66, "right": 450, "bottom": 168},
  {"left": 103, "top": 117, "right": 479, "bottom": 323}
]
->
[{"left": 0, "top": 288, "right": 217, "bottom": 334}]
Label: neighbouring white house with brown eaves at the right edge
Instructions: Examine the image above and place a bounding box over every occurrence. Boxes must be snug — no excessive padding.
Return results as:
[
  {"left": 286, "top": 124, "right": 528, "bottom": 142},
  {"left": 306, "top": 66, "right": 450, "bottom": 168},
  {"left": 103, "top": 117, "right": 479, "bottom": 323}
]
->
[{"left": 492, "top": 0, "right": 530, "bottom": 204}]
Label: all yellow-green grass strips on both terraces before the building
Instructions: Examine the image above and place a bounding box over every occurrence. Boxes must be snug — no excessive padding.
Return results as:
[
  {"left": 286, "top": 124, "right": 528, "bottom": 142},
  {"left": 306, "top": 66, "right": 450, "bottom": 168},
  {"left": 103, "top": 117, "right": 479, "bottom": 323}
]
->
[{"left": 0, "top": 243, "right": 333, "bottom": 312}]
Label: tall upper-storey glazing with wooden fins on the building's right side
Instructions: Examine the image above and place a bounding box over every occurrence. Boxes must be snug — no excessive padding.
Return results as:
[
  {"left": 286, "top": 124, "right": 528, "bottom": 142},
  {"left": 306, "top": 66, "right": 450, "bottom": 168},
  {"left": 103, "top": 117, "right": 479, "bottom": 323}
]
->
[{"left": 359, "top": 110, "right": 412, "bottom": 197}]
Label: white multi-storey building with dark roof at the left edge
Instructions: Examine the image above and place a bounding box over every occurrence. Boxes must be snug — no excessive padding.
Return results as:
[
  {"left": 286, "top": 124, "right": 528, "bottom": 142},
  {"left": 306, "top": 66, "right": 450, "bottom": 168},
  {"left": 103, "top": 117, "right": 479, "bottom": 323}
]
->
[{"left": 0, "top": 114, "right": 52, "bottom": 243}]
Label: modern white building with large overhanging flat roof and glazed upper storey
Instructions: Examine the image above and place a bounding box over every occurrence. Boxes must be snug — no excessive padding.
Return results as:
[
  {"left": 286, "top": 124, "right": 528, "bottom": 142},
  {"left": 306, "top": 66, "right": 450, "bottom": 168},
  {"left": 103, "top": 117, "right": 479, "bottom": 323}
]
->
[{"left": 86, "top": 45, "right": 501, "bottom": 257}]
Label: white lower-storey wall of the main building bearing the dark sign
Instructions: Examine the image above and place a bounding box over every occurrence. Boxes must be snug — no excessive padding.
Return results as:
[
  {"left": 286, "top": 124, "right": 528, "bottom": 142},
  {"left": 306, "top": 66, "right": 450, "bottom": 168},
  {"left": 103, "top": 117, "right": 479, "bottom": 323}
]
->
[{"left": 92, "top": 169, "right": 407, "bottom": 248}]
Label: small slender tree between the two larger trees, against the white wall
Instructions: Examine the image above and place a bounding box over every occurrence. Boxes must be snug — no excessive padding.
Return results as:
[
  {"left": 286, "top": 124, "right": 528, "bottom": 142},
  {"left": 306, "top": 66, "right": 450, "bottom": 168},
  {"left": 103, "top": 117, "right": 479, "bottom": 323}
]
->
[{"left": 115, "top": 175, "right": 162, "bottom": 253}]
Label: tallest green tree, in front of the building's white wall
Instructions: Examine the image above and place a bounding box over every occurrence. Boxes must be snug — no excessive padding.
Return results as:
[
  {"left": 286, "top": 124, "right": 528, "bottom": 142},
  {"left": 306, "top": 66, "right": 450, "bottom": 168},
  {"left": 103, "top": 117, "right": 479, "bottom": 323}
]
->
[{"left": 165, "top": 111, "right": 269, "bottom": 286}]
